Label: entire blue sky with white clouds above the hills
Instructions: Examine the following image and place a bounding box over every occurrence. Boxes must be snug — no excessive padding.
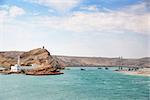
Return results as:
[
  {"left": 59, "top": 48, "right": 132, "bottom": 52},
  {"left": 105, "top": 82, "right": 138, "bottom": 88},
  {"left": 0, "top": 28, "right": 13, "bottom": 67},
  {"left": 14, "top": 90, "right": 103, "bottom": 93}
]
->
[{"left": 0, "top": 0, "right": 150, "bottom": 58}]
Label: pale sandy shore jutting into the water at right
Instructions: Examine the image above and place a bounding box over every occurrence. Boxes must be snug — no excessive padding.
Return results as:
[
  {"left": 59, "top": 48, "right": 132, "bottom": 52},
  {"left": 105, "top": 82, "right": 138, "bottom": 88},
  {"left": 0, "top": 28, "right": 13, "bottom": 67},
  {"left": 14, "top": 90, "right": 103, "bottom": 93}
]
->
[{"left": 118, "top": 68, "right": 150, "bottom": 77}]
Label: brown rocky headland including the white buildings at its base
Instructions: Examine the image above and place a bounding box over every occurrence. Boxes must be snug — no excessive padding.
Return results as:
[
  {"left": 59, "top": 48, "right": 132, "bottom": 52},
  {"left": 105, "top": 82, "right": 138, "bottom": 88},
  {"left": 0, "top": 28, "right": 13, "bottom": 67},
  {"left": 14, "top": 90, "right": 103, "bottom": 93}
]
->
[{"left": 0, "top": 48, "right": 63, "bottom": 75}]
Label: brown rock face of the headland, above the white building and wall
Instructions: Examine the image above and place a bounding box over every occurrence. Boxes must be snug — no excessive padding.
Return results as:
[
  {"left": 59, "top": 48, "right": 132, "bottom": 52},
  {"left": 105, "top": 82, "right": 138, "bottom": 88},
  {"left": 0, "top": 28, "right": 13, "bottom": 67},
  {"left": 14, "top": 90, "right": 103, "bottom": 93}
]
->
[{"left": 0, "top": 48, "right": 60, "bottom": 68}]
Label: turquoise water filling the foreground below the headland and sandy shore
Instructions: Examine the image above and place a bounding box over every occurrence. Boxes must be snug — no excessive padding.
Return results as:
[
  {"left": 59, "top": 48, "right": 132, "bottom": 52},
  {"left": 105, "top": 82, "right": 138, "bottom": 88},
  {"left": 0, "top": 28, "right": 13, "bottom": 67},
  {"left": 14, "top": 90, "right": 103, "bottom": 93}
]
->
[{"left": 0, "top": 68, "right": 150, "bottom": 100}]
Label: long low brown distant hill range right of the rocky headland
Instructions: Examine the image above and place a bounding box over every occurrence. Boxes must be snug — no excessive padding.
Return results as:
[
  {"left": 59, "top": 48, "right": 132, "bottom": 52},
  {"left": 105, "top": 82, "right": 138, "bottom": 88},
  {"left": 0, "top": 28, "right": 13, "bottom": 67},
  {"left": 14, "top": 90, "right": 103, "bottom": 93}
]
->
[{"left": 54, "top": 56, "right": 150, "bottom": 67}]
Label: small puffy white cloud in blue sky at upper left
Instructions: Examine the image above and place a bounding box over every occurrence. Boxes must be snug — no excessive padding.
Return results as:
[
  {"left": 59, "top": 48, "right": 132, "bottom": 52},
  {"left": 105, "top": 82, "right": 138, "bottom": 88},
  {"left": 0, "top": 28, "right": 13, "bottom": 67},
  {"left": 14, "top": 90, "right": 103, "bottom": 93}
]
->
[{"left": 9, "top": 6, "right": 25, "bottom": 17}]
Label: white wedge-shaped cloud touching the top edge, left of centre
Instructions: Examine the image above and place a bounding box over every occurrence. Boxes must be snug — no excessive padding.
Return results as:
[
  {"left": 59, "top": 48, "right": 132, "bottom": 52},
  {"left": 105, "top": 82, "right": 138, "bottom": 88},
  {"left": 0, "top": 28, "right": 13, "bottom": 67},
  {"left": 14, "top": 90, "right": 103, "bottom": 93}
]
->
[{"left": 26, "top": 0, "right": 81, "bottom": 12}]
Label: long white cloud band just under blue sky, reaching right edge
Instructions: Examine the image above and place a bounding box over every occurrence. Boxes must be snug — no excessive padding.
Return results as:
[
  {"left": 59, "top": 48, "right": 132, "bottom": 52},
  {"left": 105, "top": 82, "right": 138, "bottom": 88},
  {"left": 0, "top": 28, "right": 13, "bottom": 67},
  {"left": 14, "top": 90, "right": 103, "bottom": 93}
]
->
[{"left": 28, "top": 12, "right": 150, "bottom": 35}]
